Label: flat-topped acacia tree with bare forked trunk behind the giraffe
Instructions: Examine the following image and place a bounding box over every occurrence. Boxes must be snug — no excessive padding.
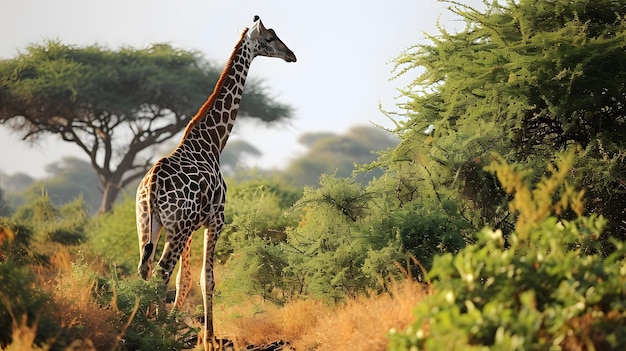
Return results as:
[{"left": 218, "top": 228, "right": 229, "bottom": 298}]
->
[{"left": 0, "top": 41, "right": 292, "bottom": 213}]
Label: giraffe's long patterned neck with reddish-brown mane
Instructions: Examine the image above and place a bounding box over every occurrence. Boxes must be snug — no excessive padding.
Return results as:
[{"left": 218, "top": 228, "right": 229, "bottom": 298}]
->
[{"left": 178, "top": 29, "right": 254, "bottom": 157}]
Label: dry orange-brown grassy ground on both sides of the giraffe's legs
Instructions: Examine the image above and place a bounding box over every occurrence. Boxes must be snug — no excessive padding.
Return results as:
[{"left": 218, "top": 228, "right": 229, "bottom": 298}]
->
[{"left": 2, "top": 245, "right": 428, "bottom": 351}]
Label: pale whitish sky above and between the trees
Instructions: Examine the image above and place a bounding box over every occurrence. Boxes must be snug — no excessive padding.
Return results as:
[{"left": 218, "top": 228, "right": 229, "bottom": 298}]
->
[{"left": 0, "top": 0, "right": 481, "bottom": 177}]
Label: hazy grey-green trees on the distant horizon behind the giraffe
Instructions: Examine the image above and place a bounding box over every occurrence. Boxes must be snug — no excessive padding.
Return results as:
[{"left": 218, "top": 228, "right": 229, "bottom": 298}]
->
[{"left": 0, "top": 126, "right": 398, "bottom": 215}]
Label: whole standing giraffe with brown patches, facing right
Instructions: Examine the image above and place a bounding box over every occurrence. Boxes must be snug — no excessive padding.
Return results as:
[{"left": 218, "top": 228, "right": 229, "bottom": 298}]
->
[{"left": 136, "top": 16, "right": 296, "bottom": 350}]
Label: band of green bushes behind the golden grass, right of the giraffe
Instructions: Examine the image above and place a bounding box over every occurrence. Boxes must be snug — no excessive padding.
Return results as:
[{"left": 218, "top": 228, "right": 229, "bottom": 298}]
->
[{"left": 219, "top": 169, "right": 469, "bottom": 303}]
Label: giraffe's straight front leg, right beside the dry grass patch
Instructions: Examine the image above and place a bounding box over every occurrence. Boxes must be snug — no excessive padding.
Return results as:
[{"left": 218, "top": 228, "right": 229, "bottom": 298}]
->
[{"left": 200, "top": 221, "right": 221, "bottom": 350}]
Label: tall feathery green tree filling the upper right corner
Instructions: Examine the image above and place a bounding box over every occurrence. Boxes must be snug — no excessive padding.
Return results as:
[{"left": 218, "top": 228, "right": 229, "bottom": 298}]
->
[{"left": 388, "top": 0, "right": 626, "bottom": 236}]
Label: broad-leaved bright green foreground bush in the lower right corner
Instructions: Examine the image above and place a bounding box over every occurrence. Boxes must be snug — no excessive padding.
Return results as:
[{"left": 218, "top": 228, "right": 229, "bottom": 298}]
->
[{"left": 389, "top": 154, "right": 626, "bottom": 350}]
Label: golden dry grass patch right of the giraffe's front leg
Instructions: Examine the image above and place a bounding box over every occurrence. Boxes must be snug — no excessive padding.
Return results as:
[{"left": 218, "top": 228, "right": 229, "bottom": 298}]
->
[{"left": 219, "top": 280, "right": 427, "bottom": 351}]
